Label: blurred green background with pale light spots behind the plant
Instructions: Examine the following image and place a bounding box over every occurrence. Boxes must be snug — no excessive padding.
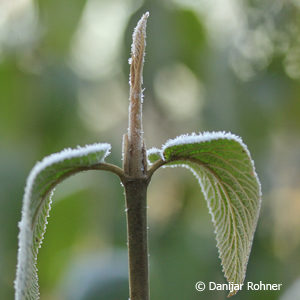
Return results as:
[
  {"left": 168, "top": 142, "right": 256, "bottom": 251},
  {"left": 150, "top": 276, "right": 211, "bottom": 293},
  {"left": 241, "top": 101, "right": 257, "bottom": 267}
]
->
[{"left": 0, "top": 0, "right": 300, "bottom": 300}]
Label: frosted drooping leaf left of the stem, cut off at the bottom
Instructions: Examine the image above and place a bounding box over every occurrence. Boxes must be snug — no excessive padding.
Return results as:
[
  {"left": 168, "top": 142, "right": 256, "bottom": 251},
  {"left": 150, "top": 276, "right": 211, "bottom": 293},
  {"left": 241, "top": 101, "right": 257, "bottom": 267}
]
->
[{"left": 15, "top": 144, "right": 110, "bottom": 300}]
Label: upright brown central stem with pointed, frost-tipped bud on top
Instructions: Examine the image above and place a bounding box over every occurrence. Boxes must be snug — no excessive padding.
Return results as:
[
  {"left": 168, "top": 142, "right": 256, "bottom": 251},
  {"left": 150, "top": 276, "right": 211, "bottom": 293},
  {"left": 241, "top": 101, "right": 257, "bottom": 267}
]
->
[{"left": 123, "top": 13, "right": 149, "bottom": 300}]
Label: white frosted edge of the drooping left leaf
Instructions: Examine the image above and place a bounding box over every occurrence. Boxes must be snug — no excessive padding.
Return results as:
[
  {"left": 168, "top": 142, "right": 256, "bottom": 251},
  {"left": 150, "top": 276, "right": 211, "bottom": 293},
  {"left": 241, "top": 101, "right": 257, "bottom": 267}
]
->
[{"left": 14, "top": 143, "right": 111, "bottom": 300}]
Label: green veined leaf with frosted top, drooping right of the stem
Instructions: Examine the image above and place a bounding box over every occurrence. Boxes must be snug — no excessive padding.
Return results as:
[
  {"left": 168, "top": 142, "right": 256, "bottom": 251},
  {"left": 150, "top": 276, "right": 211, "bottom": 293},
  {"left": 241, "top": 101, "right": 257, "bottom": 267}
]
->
[{"left": 152, "top": 132, "right": 261, "bottom": 296}]
